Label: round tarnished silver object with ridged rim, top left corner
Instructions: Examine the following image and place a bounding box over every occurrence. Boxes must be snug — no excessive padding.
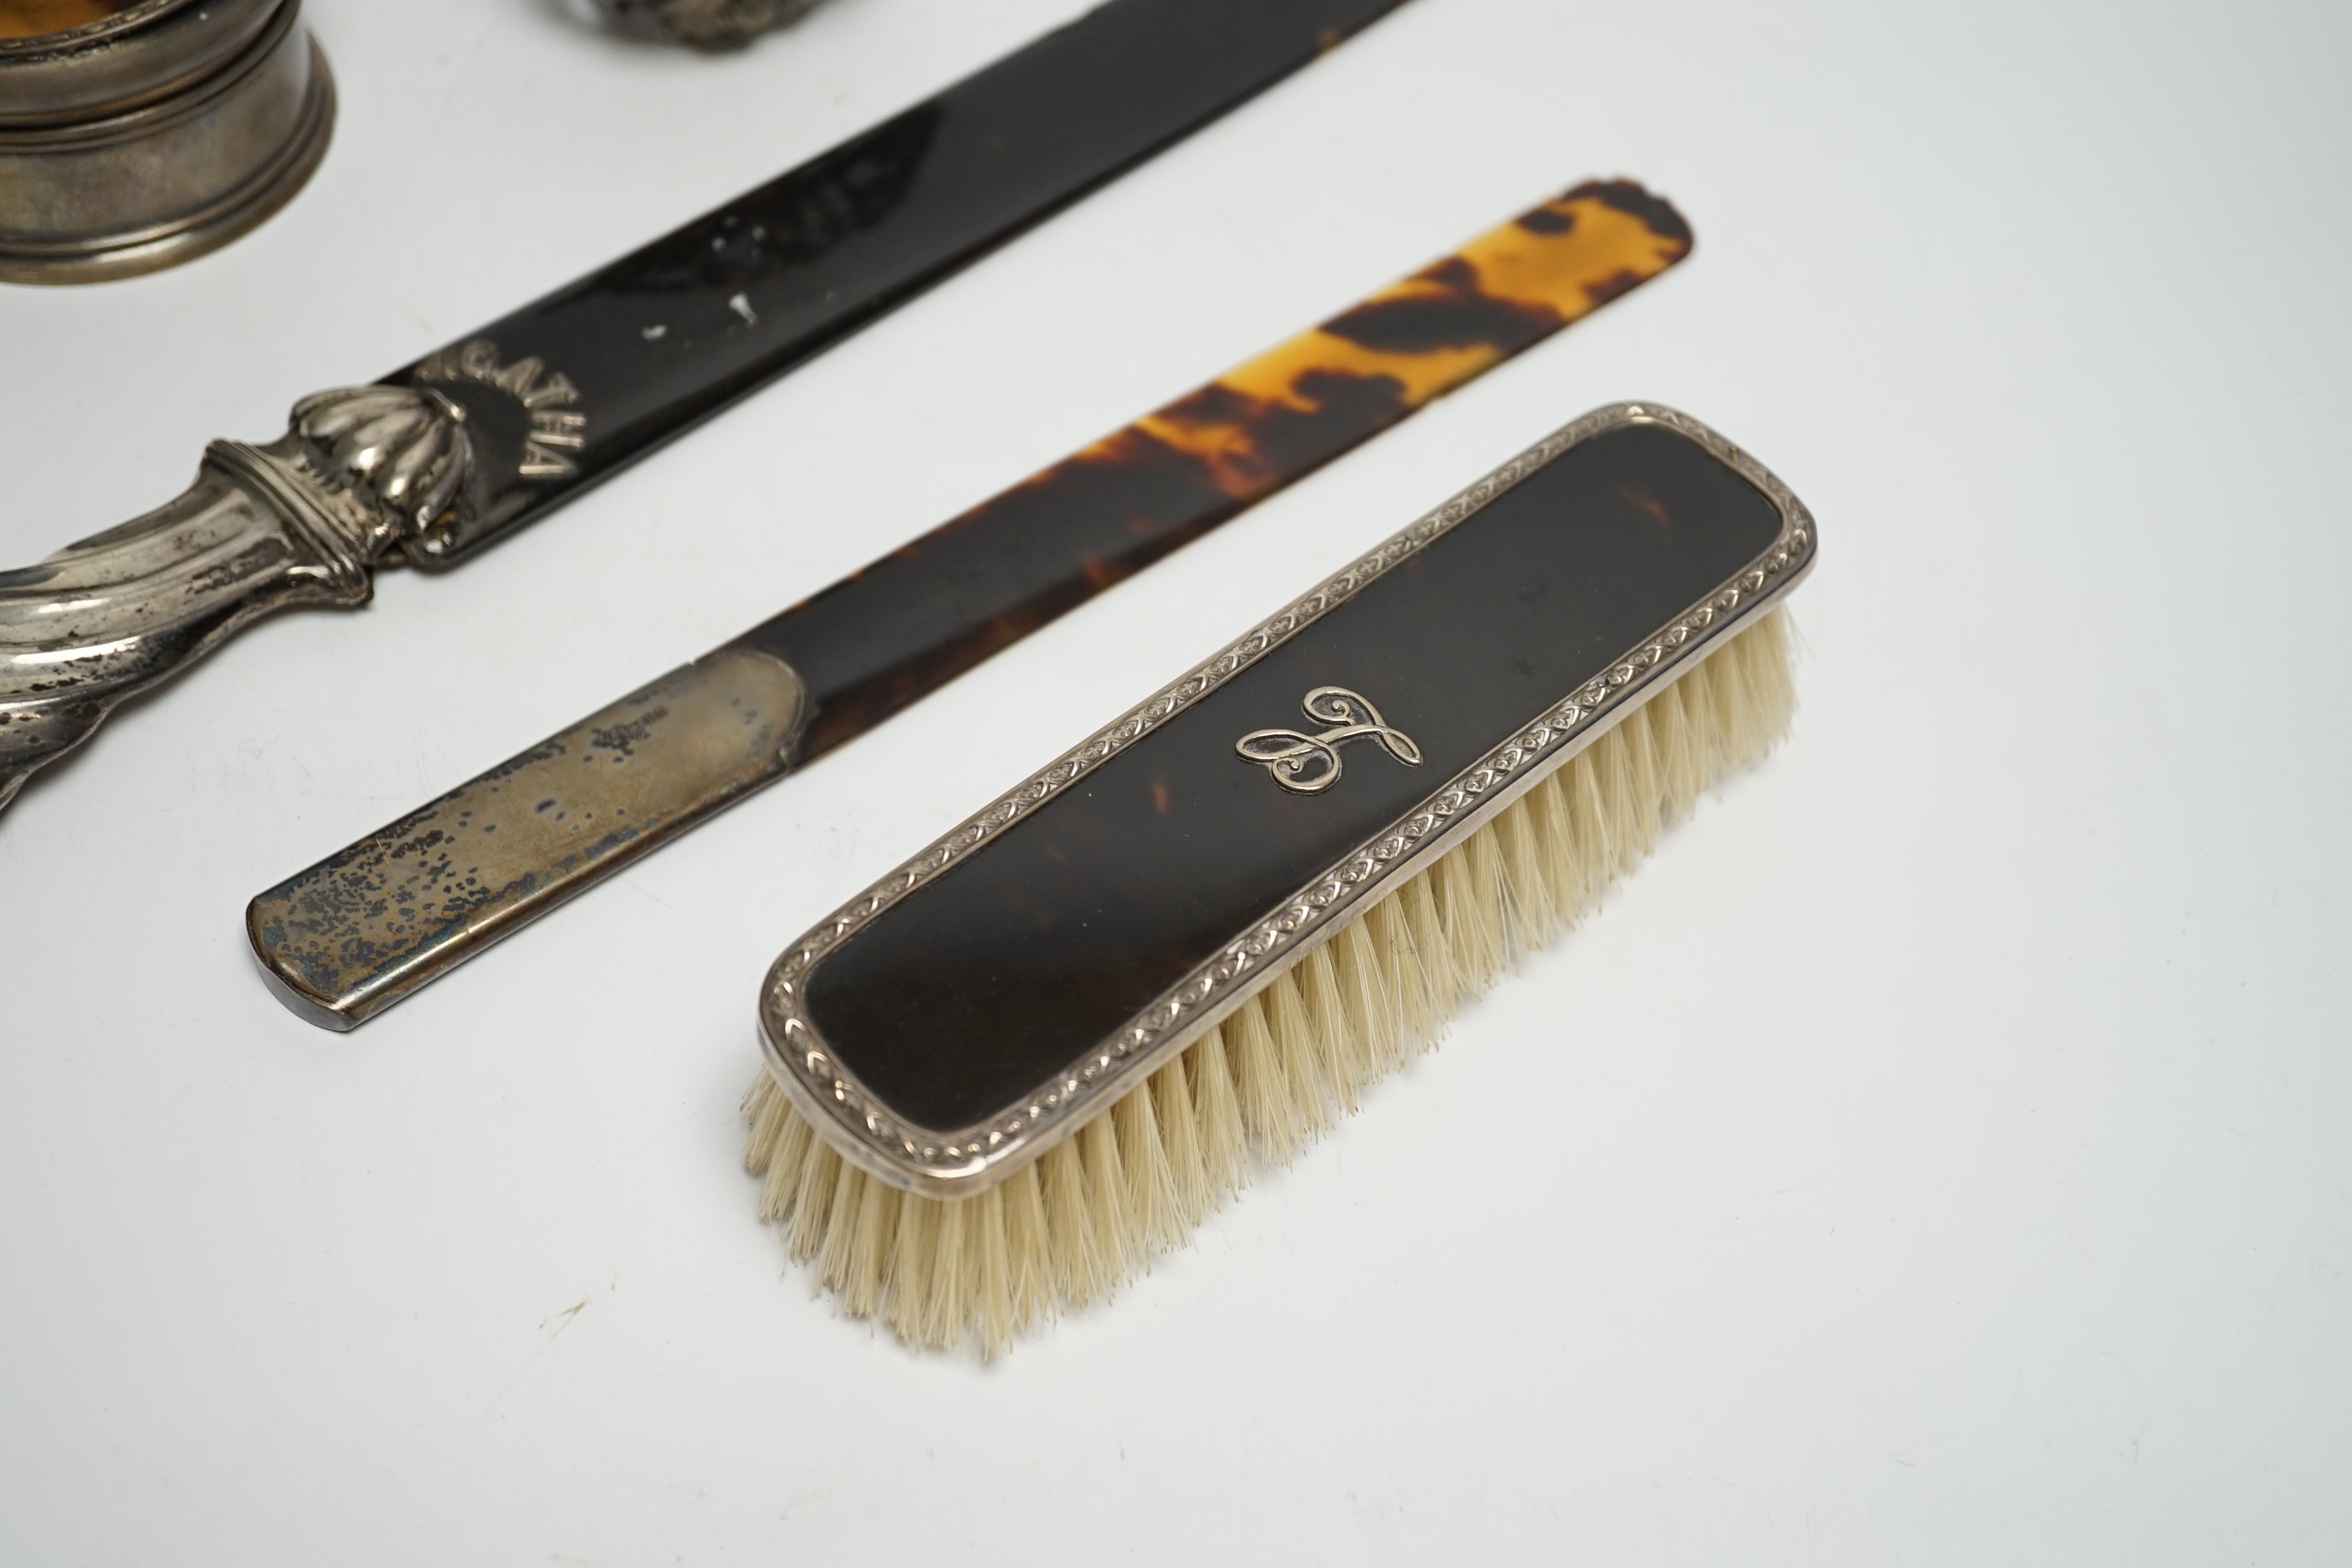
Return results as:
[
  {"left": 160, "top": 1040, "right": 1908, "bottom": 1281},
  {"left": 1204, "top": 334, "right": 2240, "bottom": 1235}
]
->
[{"left": 0, "top": 0, "right": 334, "bottom": 282}]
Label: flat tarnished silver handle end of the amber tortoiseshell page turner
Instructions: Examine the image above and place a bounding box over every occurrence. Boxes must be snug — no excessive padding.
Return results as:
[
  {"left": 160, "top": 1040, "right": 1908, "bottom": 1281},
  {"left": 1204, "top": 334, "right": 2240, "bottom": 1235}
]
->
[{"left": 244, "top": 647, "right": 809, "bottom": 1030}]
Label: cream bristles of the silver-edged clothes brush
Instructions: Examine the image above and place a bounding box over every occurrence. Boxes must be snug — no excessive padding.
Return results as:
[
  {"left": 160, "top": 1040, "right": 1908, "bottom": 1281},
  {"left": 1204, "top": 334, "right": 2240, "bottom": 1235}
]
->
[{"left": 743, "top": 611, "right": 1797, "bottom": 1356}]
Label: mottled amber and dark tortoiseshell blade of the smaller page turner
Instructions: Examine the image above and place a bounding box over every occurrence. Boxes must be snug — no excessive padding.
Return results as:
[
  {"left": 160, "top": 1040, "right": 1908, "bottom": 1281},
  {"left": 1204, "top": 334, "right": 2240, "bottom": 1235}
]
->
[{"left": 739, "top": 181, "right": 1691, "bottom": 759}]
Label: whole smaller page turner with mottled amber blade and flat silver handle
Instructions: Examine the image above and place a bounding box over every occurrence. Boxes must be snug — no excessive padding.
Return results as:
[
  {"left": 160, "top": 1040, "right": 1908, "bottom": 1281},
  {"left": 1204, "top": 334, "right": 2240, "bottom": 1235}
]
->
[{"left": 247, "top": 181, "right": 1691, "bottom": 1030}]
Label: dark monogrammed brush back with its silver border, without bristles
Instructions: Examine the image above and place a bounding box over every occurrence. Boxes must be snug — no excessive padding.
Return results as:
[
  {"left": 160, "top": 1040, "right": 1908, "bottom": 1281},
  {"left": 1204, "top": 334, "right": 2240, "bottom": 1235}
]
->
[{"left": 760, "top": 402, "right": 1813, "bottom": 1199}]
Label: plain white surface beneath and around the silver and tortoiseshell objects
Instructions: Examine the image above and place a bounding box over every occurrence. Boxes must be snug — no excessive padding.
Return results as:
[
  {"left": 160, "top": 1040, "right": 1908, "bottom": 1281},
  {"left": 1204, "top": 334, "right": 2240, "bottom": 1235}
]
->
[{"left": 0, "top": 0, "right": 2352, "bottom": 1565}]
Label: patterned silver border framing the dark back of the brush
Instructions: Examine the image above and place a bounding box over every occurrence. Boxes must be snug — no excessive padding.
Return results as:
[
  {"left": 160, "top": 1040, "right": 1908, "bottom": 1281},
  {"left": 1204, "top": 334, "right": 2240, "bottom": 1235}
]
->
[{"left": 760, "top": 402, "right": 1813, "bottom": 1196}]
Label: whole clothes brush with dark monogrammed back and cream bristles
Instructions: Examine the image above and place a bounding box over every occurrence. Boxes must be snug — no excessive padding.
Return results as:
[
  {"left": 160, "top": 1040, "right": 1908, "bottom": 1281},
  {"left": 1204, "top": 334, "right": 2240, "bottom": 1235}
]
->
[{"left": 743, "top": 404, "right": 1813, "bottom": 1354}]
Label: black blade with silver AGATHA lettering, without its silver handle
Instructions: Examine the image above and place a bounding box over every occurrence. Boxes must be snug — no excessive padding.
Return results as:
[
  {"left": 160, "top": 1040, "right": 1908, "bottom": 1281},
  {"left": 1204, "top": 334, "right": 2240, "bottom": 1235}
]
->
[{"left": 391, "top": 0, "right": 1404, "bottom": 569}]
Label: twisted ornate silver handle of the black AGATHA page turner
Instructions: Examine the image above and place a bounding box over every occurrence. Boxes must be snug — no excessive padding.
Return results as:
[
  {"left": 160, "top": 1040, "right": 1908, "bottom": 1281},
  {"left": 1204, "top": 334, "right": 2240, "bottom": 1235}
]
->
[{"left": 0, "top": 386, "right": 473, "bottom": 807}]
